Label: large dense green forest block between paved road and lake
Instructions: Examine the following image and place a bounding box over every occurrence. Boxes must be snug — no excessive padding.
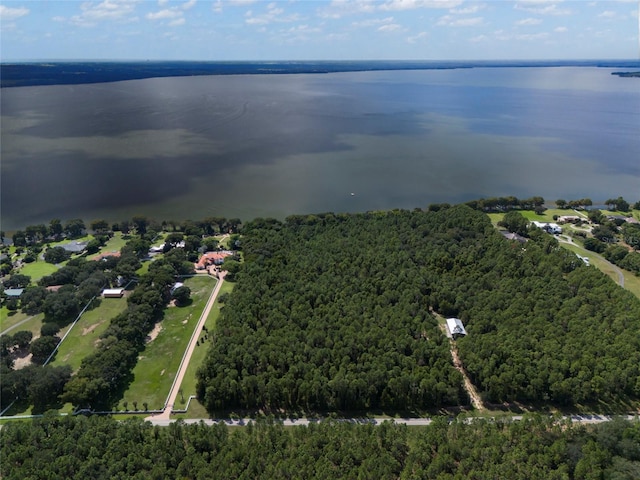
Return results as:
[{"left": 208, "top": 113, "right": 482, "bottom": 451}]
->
[{"left": 198, "top": 205, "right": 640, "bottom": 412}]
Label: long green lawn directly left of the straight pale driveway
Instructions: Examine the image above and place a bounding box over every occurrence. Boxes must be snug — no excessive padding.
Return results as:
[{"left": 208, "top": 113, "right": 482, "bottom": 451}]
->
[{"left": 119, "top": 275, "right": 216, "bottom": 410}]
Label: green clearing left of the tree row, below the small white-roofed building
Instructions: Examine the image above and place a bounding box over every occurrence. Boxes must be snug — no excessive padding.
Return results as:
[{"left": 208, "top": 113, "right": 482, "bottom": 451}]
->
[{"left": 51, "top": 297, "right": 127, "bottom": 372}]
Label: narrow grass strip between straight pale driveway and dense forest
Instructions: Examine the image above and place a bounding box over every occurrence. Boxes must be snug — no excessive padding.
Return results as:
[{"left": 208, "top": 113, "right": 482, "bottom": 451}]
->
[{"left": 175, "top": 282, "right": 234, "bottom": 418}]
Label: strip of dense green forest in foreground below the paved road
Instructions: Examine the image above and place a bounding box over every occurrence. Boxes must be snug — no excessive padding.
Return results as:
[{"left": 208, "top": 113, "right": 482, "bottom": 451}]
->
[{"left": 0, "top": 416, "right": 640, "bottom": 480}]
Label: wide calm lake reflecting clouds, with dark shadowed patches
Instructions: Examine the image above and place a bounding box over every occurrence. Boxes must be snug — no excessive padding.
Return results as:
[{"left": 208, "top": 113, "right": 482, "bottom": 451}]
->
[{"left": 0, "top": 67, "right": 640, "bottom": 231}]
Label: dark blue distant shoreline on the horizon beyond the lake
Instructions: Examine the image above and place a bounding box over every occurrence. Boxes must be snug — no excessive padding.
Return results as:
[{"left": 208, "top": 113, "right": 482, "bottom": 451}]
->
[{"left": 0, "top": 60, "right": 640, "bottom": 88}]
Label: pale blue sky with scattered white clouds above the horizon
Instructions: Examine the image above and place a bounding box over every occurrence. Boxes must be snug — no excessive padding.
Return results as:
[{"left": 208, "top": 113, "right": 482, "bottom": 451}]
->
[{"left": 0, "top": 0, "right": 640, "bottom": 61}]
